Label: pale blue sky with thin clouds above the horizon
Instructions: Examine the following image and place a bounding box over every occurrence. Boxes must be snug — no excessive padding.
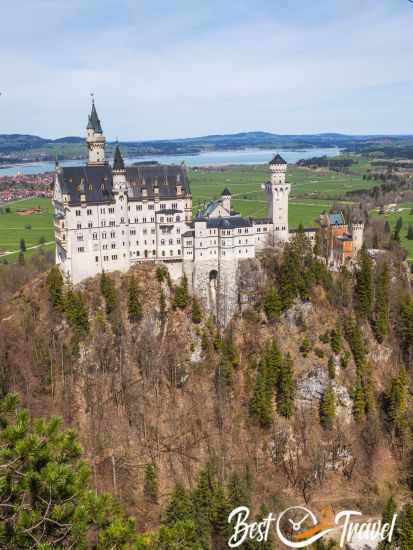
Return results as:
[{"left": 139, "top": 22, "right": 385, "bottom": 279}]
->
[{"left": 0, "top": 0, "right": 413, "bottom": 141}]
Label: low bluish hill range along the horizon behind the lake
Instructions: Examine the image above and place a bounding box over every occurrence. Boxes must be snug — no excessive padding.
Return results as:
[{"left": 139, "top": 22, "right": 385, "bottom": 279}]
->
[{"left": 0, "top": 131, "right": 413, "bottom": 162}]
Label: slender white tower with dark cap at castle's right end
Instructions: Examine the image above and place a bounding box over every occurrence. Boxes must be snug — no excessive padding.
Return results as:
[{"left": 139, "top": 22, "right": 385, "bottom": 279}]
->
[{"left": 265, "top": 155, "right": 291, "bottom": 242}]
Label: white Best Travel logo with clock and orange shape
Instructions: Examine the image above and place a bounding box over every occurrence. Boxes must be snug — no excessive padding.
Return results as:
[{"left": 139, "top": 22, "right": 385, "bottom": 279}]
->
[{"left": 228, "top": 506, "right": 397, "bottom": 548}]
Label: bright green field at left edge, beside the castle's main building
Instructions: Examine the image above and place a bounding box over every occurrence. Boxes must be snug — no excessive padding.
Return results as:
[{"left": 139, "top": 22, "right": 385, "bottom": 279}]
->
[{"left": 0, "top": 198, "right": 54, "bottom": 261}]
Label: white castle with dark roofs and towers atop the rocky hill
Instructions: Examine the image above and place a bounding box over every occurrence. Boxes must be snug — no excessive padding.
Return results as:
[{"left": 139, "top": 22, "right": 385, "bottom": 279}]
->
[{"left": 53, "top": 103, "right": 364, "bottom": 323}]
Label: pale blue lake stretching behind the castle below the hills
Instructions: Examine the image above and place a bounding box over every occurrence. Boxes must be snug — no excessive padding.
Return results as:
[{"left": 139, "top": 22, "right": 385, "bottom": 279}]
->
[{"left": 0, "top": 147, "right": 340, "bottom": 176}]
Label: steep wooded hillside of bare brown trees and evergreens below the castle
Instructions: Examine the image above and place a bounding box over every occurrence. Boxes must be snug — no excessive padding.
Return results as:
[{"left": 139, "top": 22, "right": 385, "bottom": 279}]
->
[{"left": 0, "top": 235, "right": 413, "bottom": 550}]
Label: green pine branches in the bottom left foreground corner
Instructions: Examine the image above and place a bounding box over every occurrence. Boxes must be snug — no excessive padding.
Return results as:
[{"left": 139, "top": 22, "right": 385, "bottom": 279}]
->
[{"left": 0, "top": 395, "right": 138, "bottom": 550}]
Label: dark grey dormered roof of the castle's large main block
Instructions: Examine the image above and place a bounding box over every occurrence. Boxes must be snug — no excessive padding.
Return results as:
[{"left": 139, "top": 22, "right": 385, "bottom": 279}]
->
[{"left": 58, "top": 164, "right": 191, "bottom": 206}]
